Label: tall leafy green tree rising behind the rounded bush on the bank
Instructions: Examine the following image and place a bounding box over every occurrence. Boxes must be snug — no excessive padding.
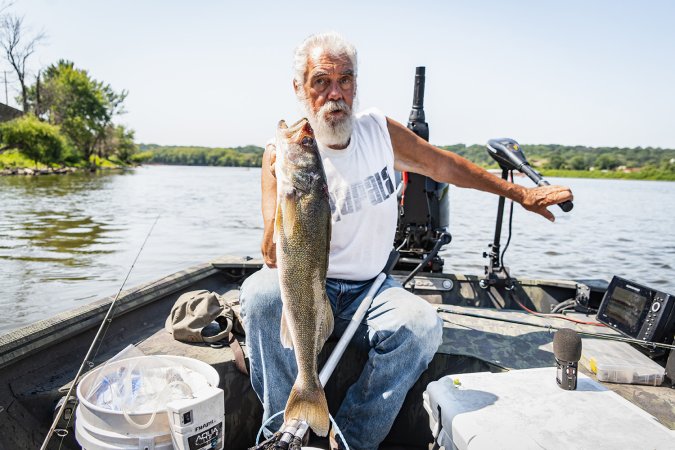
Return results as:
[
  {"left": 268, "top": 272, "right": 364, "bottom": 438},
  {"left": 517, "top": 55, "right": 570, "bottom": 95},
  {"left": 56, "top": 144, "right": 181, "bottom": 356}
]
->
[{"left": 28, "top": 60, "right": 127, "bottom": 162}]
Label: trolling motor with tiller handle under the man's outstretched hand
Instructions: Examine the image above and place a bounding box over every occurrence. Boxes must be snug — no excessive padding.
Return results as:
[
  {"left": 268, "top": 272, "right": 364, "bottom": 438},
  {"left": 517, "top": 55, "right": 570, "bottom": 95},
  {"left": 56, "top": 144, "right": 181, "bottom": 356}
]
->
[{"left": 480, "top": 138, "right": 574, "bottom": 289}]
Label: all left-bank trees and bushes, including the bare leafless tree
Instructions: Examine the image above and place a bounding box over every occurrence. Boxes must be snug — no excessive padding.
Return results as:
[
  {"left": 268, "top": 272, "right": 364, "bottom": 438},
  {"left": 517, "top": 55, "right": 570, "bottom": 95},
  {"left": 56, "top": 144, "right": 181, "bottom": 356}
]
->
[{"left": 0, "top": 8, "right": 137, "bottom": 171}]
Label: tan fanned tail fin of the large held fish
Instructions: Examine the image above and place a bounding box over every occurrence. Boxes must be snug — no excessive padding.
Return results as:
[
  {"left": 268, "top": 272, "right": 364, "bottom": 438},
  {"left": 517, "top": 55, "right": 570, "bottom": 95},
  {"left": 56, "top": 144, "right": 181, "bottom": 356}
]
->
[{"left": 284, "top": 377, "right": 330, "bottom": 436}]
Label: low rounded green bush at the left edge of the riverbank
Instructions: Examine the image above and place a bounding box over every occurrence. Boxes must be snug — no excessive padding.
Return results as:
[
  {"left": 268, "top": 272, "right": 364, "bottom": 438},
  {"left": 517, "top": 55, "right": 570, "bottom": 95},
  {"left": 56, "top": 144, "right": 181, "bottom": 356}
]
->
[{"left": 0, "top": 114, "right": 68, "bottom": 165}]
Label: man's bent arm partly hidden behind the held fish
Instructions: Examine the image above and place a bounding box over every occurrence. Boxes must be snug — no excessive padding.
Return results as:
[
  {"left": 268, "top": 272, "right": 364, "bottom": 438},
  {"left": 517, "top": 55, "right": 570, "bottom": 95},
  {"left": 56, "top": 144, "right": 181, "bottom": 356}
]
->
[{"left": 260, "top": 144, "right": 277, "bottom": 268}]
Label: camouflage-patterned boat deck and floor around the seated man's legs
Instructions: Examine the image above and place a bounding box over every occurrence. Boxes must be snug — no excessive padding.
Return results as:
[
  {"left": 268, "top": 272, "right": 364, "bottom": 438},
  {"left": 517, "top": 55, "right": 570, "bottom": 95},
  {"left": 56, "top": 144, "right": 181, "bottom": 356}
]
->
[{"left": 113, "top": 290, "right": 675, "bottom": 444}]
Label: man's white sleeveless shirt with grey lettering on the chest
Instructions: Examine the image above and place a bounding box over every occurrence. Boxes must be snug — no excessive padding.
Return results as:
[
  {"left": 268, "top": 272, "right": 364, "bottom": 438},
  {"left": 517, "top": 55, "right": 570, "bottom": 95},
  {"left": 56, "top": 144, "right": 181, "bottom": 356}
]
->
[{"left": 317, "top": 109, "right": 398, "bottom": 281}]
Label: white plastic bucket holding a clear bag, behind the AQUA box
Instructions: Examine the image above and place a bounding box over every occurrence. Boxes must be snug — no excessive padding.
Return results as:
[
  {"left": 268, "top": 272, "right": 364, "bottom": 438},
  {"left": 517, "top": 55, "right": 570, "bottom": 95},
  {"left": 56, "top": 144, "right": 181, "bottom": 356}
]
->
[{"left": 75, "top": 355, "right": 220, "bottom": 450}]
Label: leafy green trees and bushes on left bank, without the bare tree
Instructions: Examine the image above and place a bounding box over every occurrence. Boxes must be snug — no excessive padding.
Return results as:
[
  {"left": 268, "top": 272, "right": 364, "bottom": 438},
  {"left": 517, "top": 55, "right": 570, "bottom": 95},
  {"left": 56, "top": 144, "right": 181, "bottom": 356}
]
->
[{"left": 0, "top": 61, "right": 137, "bottom": 170}]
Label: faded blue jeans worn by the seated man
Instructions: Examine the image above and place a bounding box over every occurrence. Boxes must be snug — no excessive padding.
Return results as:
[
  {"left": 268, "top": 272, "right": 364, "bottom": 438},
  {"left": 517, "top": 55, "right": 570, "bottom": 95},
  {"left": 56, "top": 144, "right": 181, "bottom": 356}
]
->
[{"left": 240, "top": 267, "right": 443, "bottom": 450}]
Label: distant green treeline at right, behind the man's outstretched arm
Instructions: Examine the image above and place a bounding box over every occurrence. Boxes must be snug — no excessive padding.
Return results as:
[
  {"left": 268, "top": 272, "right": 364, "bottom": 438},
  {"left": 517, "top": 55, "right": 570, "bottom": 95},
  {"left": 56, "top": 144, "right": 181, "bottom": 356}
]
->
[{"left": 441, "top": 144, "right": 675, "bottom": 180}]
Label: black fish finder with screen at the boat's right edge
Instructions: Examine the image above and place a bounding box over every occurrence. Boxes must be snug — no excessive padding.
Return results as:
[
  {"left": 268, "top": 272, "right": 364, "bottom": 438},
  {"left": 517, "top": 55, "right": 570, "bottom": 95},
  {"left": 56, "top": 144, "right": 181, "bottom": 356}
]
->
[{"left": 597, "top": 276, "right": 675, "bottom": 344}]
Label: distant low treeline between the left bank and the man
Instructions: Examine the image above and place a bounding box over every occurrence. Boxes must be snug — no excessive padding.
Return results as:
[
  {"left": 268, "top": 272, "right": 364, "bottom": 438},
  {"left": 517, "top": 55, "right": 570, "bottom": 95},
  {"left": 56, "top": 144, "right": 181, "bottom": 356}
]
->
[{"left": 138, "top": 144, "right": 263, "bottom": 167}]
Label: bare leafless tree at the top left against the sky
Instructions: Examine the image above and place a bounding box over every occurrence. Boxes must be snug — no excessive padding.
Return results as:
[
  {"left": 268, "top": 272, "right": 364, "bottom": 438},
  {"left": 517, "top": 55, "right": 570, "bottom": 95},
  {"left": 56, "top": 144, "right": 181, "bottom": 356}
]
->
[{"left": 0, "top": 13, "right": 46, "bottom": 112}]
